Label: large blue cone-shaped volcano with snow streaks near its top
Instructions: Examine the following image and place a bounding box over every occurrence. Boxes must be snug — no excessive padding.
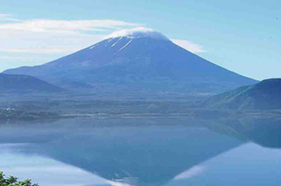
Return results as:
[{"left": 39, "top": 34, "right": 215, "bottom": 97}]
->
[{"left": 4, "top": 28, "right": 257, "bottom": 93}]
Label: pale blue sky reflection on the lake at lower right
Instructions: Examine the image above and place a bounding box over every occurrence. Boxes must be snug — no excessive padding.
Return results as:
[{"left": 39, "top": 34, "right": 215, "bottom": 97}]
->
[{"left": 166, "top": 143, "right": 281, "bottom": 186}]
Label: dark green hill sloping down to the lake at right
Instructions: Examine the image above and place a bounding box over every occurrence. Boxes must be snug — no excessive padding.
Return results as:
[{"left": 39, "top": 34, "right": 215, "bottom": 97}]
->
[{"left": 203, "top": 79, "right": 281, "bottom": 110}]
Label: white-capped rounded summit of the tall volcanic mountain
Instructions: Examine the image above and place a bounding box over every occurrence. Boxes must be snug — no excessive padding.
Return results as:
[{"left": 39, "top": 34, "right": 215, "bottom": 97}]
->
[{"left": 107, "top": 27, "right": 169, "bottom": 40}]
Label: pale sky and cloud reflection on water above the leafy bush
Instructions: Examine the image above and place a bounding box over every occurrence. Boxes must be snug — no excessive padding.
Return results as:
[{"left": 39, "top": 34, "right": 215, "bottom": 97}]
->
[{"left": 0, "top": 144, "right": 108, "bottom": 186}]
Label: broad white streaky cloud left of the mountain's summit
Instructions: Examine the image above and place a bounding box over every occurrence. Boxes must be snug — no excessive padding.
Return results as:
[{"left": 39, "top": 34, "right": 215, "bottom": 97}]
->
[{"left": 0, "top": 14, "right": 139, "bottom": 59}]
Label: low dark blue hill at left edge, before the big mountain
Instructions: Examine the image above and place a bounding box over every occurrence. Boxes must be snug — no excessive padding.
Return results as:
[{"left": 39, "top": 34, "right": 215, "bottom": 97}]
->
[{"left": 0, "top": 74, "right": 62, "bottom": 93}]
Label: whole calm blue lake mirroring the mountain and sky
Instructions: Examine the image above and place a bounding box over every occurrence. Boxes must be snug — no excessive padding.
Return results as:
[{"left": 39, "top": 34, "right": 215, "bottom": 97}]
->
[{"left": 0, "top": 118, "right": 281, "bottom": 186}]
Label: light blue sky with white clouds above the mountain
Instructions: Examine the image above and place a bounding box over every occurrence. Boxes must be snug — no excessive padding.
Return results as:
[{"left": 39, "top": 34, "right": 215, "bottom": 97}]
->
[{"left": 0, "top": 0, "right": 281, "bottom": 80}]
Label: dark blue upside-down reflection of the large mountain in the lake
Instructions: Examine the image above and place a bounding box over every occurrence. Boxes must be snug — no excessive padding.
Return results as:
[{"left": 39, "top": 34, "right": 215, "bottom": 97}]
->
[{"left": 37, "top": 127, "right": 241, "bottom": 185}]
